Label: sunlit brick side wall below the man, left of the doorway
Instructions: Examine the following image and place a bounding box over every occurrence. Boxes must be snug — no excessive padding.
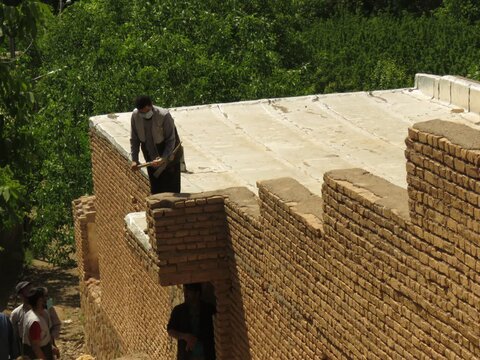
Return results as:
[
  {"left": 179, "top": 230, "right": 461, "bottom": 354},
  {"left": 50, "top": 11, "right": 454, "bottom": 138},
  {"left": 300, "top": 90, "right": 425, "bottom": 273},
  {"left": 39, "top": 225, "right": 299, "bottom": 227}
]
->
[{"left": 74, "top": 129, "right": 181, "bottom": 359}]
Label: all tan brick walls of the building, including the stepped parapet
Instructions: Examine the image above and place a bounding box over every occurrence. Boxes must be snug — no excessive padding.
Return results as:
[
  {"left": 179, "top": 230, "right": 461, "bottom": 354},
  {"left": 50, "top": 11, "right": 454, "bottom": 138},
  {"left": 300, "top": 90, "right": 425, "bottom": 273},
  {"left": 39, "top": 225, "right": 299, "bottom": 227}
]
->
[{"left": 76, "top": 120, "right": 480, "bottom": 360}]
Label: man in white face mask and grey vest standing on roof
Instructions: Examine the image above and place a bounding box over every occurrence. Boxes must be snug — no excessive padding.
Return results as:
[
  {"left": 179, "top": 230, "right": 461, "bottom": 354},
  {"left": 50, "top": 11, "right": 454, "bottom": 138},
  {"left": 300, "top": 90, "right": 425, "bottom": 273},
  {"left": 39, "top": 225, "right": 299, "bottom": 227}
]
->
[{"left": 130, "top": 95, "right": 183, "bottom": 194}]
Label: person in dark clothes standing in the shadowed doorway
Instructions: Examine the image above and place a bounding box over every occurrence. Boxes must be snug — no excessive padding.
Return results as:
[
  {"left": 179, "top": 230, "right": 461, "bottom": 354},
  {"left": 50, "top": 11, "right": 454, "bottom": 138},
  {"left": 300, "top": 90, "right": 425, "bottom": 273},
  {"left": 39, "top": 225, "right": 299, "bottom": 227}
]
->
[{"left": 167, "top": 283, "right": 215, "bottom": 360}]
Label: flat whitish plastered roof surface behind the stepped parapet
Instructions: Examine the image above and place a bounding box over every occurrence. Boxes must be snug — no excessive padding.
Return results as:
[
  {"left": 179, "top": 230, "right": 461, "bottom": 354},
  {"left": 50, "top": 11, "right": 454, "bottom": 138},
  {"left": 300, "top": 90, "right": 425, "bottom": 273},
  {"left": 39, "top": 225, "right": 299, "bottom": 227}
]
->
[{"left": 90, "top": 74, "right": 480, "bottom": 195}]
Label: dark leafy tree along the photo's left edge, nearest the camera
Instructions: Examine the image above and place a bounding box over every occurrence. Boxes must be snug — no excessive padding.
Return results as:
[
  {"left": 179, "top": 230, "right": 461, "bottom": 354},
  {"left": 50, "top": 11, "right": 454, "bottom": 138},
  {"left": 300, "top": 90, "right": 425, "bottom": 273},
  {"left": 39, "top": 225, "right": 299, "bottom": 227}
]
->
[{"left": 0, "top": 0, "right": 46, "bottom": 256}]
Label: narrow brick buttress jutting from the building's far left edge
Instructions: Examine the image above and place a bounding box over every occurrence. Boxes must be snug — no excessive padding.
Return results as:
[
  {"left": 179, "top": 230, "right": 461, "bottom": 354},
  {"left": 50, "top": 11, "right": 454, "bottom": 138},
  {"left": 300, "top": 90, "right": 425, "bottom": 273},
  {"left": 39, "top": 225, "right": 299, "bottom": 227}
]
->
[{"left": 72, "top": 196, "right": 98, "bottom": 280}]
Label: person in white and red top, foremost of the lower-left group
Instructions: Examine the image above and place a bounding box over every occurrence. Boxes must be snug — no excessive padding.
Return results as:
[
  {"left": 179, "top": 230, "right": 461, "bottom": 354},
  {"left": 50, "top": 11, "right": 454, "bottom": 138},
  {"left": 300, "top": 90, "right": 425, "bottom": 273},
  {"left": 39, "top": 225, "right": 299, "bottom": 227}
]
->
[{"left": 23, "top": 288, "right": 60, "bottom": 360}]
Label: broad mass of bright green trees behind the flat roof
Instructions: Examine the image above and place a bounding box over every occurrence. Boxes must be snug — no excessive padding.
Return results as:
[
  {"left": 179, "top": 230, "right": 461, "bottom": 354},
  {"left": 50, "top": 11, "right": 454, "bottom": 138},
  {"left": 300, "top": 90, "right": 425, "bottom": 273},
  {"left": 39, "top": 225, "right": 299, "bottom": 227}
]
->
[{"left": 0, "top": 0, "right": 480, "bottom": 263}]
